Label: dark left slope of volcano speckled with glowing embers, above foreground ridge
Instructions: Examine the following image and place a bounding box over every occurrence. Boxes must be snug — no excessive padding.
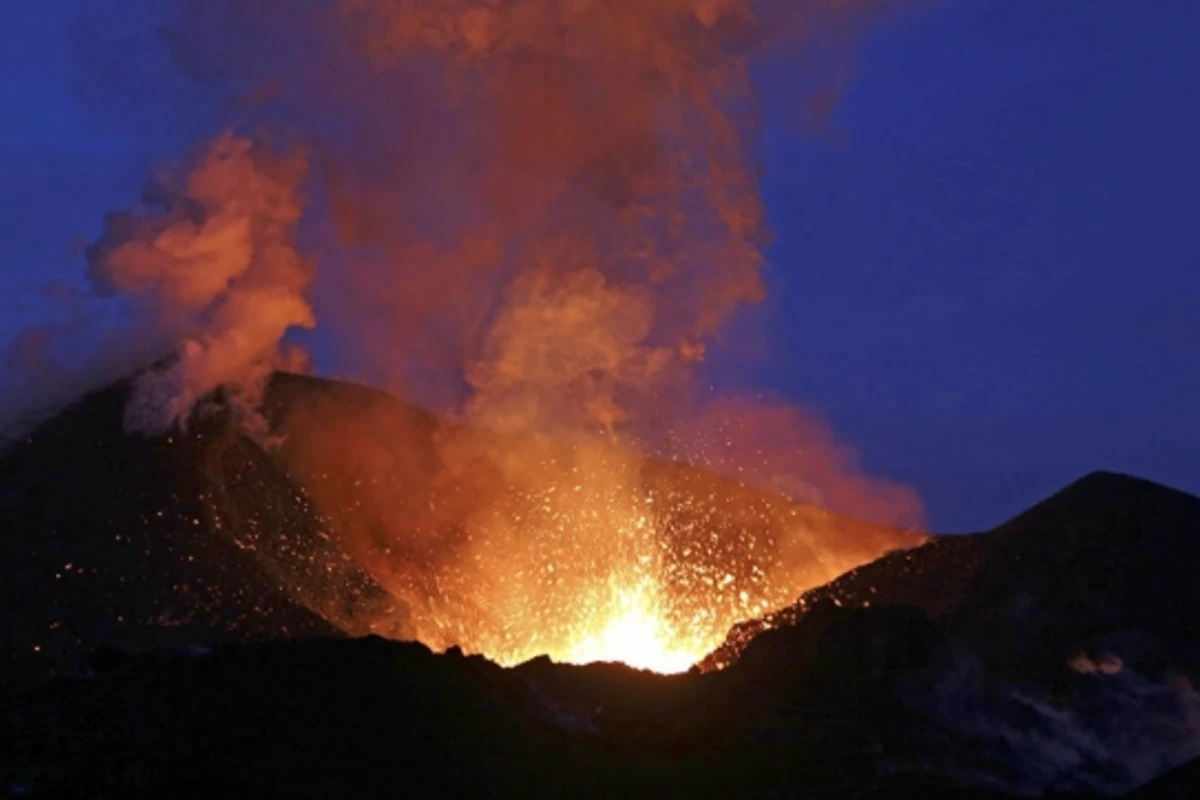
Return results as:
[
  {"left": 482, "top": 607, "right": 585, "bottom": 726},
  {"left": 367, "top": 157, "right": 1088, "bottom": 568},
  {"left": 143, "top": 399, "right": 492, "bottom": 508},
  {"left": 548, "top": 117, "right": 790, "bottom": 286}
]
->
[{"left": 0, "top": 386, "right": 367, "bottom": 681}]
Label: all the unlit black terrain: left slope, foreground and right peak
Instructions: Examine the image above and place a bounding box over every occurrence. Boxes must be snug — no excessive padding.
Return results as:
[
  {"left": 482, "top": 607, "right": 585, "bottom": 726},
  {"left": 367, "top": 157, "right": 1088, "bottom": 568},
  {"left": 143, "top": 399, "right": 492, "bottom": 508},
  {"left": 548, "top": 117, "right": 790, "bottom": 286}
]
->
[{"left": 0, "top": 384, "right": 1200, "bottom": 799}]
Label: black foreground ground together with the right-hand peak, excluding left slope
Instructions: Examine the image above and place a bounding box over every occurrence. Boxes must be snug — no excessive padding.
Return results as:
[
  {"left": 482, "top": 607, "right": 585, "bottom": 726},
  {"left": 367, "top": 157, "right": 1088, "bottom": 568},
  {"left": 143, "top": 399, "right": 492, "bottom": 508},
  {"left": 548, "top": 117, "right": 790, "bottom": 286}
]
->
[{"left": 7, "top": 474, "right": 1200, "bottom": 799}]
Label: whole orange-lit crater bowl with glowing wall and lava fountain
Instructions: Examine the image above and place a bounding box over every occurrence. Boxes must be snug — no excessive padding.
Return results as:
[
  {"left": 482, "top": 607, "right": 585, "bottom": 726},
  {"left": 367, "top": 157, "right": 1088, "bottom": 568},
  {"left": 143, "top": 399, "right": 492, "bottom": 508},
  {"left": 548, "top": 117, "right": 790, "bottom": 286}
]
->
[{"left": 270, "top": 398, "right": 919, "bottom": 672}]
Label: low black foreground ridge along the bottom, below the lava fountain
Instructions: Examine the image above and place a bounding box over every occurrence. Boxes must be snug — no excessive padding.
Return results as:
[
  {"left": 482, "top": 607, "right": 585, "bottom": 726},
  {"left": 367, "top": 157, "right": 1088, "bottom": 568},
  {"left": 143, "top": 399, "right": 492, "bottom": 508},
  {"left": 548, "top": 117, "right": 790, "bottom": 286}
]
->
[{"left": 7, "top": 573, "right": 1196, "bottom": 798}]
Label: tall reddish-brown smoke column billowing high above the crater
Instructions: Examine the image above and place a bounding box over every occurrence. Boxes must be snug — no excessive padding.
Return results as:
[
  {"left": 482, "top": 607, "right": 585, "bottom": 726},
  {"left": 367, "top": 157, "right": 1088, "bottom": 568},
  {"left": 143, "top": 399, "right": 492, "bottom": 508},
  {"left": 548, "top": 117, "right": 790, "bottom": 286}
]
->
[{"left": 142, "top": 0, "right": 878, "bottom": 431}]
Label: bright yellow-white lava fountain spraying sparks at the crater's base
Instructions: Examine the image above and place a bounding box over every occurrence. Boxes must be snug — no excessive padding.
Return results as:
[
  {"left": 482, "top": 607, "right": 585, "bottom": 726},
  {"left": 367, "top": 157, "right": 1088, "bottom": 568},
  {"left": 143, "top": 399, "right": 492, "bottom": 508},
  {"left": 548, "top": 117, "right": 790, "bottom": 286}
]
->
[{"left": 355, "top": 479, "right": 787, "bottom": 673}]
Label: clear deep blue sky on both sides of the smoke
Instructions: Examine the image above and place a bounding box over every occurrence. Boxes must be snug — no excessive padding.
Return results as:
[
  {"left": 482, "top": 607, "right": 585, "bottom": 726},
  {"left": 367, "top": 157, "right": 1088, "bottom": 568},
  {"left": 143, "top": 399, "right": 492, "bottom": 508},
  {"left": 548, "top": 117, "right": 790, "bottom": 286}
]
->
[{"left": 0, "top": 0, "right": 1200, "bottom": 530}]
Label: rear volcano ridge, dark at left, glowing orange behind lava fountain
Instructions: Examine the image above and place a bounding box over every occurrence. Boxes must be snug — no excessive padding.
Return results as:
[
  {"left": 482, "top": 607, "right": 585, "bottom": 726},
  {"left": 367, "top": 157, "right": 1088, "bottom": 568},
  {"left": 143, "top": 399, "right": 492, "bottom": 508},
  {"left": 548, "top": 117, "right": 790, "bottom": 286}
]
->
[{"left": 0, "top": 374, "right": 924, "bottom": 674}]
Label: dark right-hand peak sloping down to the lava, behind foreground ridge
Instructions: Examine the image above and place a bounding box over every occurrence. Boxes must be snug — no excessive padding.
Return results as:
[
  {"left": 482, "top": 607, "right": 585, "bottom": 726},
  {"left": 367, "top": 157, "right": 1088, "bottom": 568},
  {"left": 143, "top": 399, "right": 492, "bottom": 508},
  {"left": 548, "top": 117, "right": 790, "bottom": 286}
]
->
[{"left": 708, "top": 473, "right": 1200, "bottom": 678}]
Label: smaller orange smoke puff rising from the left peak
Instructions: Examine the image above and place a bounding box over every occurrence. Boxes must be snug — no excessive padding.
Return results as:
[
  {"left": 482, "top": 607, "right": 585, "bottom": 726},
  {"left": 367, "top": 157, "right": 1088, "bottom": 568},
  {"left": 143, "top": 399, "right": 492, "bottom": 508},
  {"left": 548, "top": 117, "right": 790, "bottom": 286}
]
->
[{"left": 88, "top": 133, "right": 316, "bottom": 434}]
